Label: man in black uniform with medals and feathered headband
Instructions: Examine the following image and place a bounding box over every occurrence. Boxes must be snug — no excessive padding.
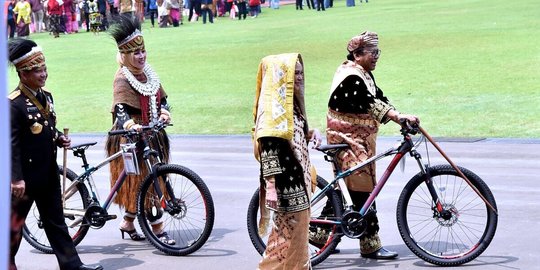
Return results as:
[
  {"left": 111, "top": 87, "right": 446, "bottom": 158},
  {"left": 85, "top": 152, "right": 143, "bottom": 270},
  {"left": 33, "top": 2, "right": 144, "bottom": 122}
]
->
[{"left": 8, "top": 39, "right": 103, "bottom": 270}]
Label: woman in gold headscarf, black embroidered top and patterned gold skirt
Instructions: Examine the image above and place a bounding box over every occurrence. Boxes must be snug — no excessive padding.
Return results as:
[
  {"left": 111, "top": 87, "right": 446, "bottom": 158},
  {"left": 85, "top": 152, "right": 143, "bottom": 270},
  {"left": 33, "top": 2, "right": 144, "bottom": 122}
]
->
[{"left": 253, "top": 53, "right": 321, "bottom": 270}]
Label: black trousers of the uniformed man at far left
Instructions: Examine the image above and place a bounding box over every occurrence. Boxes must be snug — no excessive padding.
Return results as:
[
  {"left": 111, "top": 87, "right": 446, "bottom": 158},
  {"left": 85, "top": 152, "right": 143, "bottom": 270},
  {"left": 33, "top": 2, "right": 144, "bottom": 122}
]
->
[{"left": 10, "top": 171, "right": 82, "bottom": 270}]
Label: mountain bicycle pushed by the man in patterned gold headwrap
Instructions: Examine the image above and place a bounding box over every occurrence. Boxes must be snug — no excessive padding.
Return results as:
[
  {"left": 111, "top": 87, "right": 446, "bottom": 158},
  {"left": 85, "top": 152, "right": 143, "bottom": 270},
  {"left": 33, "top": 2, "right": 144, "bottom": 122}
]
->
[{"left": 247, "top": 123, "right": 498, "bottom": 266}]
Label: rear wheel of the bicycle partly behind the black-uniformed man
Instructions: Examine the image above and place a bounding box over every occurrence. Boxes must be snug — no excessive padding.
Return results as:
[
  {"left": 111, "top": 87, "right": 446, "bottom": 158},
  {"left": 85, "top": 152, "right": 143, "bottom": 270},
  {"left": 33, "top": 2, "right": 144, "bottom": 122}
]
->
[{"left": 22, "top": 166, "right": 90, "bottom": 254}]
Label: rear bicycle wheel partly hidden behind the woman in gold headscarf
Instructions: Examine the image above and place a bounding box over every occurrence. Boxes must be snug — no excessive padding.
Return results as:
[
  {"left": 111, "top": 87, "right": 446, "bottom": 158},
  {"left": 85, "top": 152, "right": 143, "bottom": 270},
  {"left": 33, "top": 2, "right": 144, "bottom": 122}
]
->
[{"left": 247, "top": 176, "right": 343, "bottom": 266}]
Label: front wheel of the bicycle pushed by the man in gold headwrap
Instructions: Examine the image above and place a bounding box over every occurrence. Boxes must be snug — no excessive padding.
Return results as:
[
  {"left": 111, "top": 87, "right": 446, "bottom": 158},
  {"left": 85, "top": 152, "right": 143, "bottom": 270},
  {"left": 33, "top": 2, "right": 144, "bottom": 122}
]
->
[{"left": 396, "top": 165, "right": 498, "bottom": 266}]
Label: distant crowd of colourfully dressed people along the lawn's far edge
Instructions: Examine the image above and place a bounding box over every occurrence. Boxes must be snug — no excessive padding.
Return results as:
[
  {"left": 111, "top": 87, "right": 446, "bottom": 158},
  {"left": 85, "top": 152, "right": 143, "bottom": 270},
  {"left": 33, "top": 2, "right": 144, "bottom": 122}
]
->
[{"left": 4, "top": 0, "right": 368, "bottom": 38}]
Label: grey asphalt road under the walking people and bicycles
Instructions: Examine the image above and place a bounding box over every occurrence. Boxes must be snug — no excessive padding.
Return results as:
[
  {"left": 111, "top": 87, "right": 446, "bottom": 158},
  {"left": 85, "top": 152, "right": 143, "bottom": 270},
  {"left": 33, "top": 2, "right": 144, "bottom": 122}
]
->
[{"left": 17, "top": 134, "right": 540, "bottom": 270}]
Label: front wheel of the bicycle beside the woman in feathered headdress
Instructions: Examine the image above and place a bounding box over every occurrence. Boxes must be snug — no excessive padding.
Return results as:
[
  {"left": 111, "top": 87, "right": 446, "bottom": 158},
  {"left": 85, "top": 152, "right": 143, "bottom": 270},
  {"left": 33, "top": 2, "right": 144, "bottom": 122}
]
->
[{"left": 137, "top": 164, "right": 215, "bottom": 256}]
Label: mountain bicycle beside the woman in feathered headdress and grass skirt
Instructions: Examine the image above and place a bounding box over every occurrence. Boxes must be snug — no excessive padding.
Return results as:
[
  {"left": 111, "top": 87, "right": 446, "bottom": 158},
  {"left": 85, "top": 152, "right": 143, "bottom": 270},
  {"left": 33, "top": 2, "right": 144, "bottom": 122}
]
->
[{"left": 23, "top": 123, "right": 215, "bottom": 256}]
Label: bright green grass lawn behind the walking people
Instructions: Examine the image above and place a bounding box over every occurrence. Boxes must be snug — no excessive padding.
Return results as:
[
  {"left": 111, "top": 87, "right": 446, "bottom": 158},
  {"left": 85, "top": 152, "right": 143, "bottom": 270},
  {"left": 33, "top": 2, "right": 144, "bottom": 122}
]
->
[{"left": 5, "top": 0, "right": 540, "bottom": 138}]
